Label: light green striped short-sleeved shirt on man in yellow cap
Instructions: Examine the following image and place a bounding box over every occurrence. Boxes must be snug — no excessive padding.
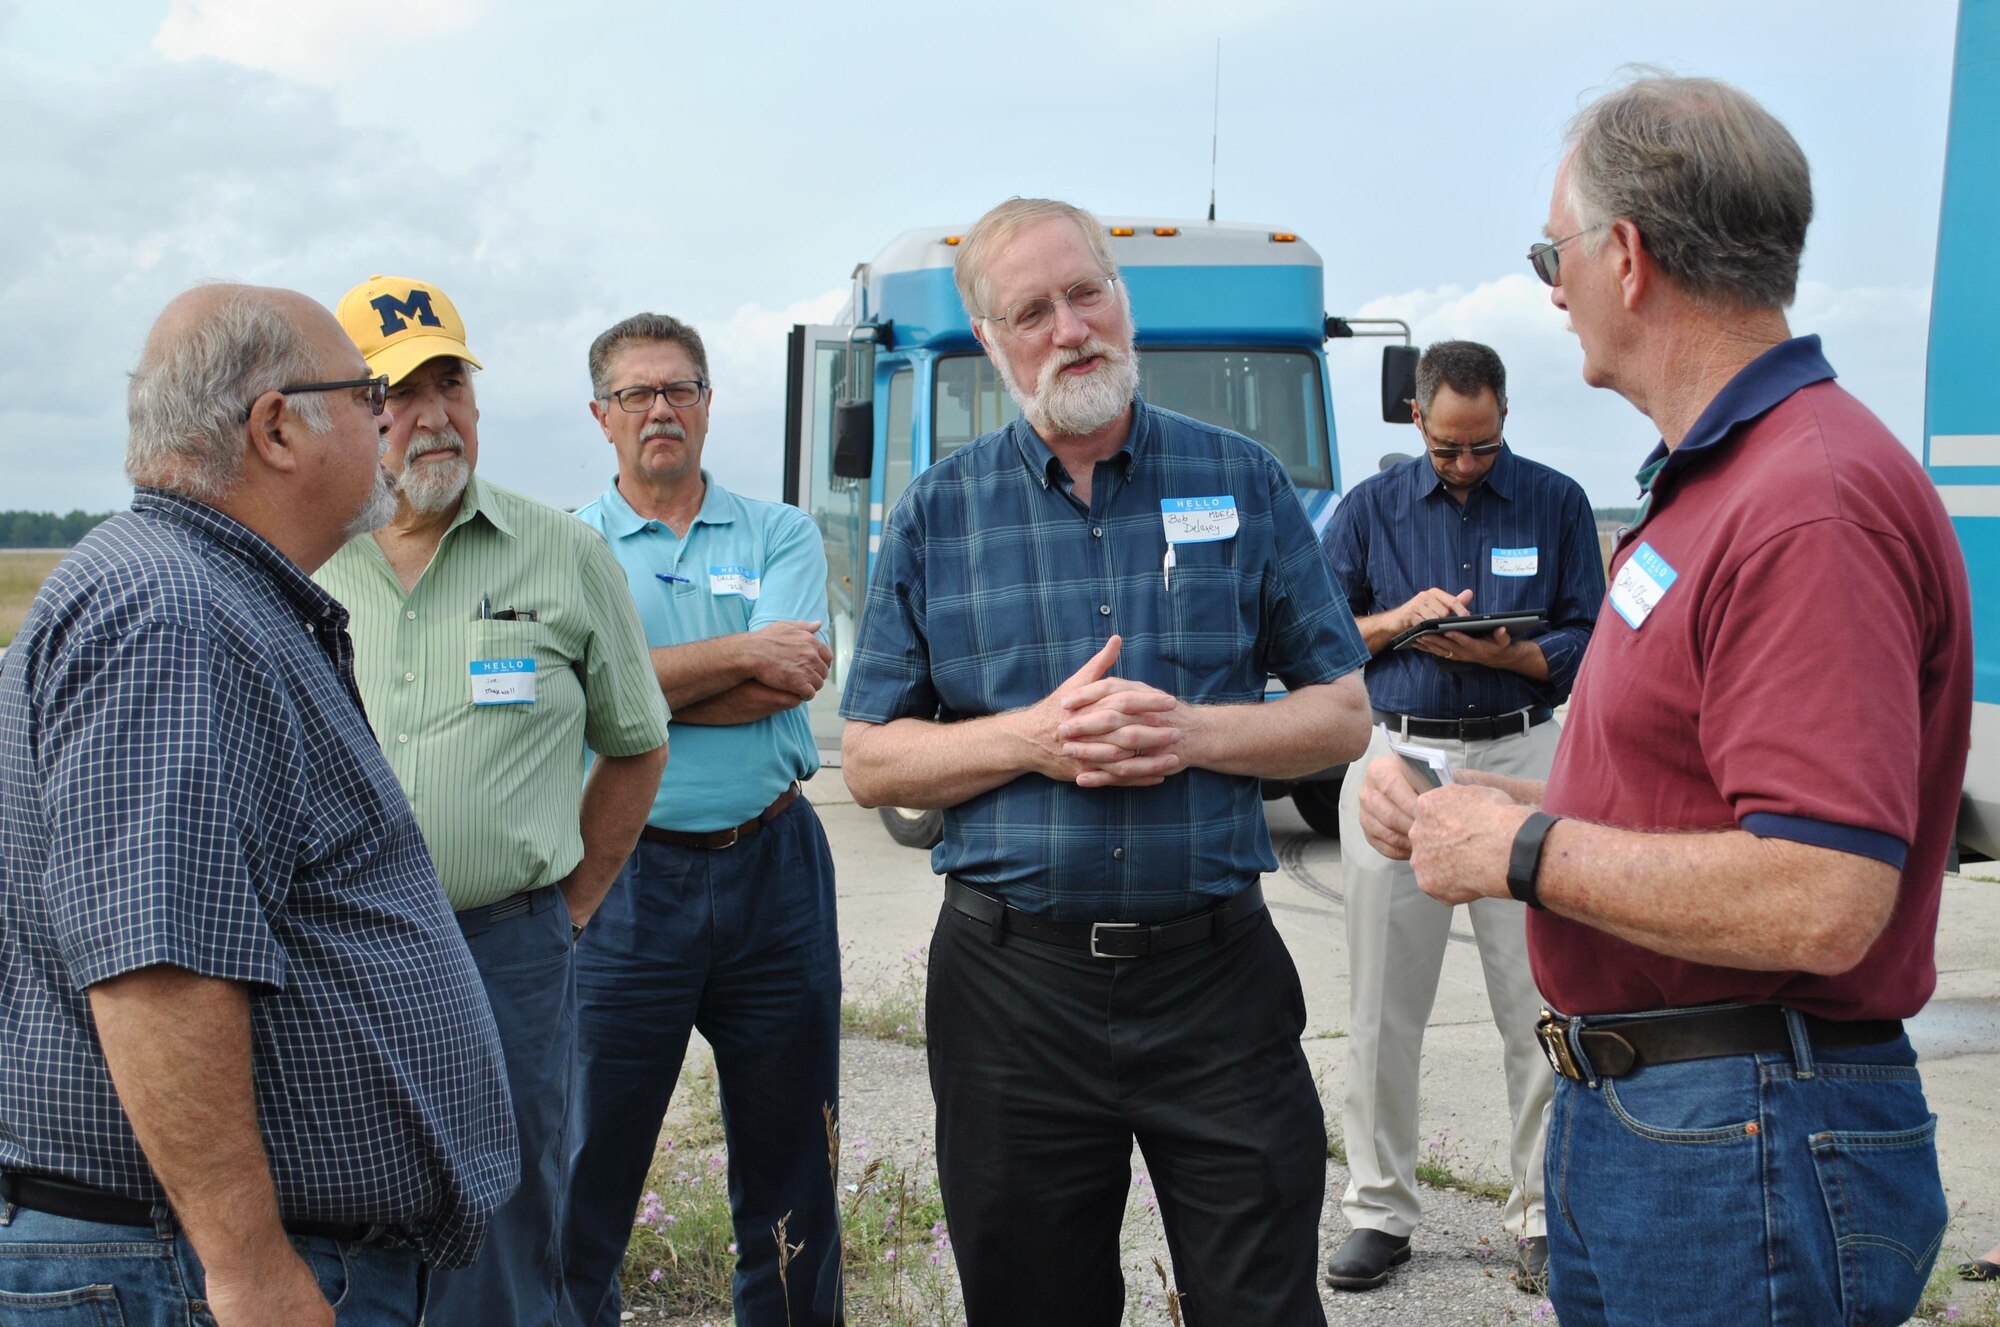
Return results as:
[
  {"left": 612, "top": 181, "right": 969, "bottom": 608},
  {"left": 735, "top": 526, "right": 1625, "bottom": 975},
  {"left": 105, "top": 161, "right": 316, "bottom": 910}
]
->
[{"left": 314, "top": 476, "right": 666, "bottom": 909}]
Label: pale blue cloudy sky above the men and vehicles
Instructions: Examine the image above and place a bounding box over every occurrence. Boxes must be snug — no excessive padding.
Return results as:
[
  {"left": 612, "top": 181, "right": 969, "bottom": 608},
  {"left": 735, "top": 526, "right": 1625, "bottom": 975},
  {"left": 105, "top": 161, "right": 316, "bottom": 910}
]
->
[{"left": 0, "top": 0, "right": 1954, "bottom": 510}]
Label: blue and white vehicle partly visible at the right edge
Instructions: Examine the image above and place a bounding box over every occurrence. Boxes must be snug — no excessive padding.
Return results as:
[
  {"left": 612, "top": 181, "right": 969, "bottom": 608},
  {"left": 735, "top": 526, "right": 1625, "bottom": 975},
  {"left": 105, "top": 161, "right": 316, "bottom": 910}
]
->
[{"left": 1924, "top": 0, "right": 2000, "bottom": 857}]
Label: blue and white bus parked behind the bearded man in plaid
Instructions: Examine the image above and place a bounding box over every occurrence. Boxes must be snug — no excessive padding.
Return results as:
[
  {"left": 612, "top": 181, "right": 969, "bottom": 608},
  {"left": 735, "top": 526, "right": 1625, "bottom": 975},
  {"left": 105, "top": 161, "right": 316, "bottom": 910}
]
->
[{"left": 784, "top": 218, "right": 1416, "bottom": 845}]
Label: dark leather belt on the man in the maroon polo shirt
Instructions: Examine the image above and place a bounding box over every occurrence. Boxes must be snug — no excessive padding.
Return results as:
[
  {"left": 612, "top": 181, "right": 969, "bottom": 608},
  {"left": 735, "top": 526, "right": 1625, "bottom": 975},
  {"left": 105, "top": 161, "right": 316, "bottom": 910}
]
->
[{"left": 1534, "top": 1005, "right": 1902, "bottom": 1083}]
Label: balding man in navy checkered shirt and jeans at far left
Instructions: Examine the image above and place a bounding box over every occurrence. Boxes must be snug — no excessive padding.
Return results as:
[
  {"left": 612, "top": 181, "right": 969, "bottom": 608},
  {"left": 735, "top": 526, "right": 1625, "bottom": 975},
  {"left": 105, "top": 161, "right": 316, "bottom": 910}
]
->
[{"left": 0, "top": 286, "right": 518, "bottom": 1327}]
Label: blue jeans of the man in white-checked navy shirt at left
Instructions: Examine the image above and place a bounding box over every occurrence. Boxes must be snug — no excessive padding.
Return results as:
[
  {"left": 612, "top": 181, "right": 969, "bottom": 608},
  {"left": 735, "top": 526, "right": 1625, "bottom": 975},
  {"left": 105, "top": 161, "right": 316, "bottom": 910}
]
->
[{"left": 0, "top": 1207, "right": 426, "bottom": 1327}]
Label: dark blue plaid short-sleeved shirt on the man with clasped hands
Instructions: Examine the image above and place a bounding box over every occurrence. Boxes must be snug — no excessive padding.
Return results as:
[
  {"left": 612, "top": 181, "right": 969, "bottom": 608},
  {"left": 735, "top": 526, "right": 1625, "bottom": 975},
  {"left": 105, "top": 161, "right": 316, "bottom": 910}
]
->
[{"left": 840, "top": 402, "right": 1368, "bottom": 921}]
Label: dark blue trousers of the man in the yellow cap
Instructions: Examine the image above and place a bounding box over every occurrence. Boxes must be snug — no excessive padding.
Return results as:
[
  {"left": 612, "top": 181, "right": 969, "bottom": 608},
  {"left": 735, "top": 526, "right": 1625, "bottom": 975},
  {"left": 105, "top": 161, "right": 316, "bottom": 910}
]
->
[{"left": 424, "top": 885, "right": 576, "bottom": 1327}]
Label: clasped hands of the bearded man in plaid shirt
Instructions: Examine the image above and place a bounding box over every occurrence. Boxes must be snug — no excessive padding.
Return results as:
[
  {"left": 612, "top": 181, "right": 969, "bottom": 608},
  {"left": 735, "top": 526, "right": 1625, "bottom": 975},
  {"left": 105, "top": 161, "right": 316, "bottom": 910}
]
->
[{"left": 1030, "top": 636, "right": 1194, "bottom": 787}]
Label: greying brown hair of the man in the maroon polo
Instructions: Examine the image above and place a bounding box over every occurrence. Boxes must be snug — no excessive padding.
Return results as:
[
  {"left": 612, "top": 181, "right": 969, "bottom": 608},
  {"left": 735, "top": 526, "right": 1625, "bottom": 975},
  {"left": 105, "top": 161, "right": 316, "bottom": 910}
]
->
[{"left": 1554, "top": 74, "right": 1812, "bottom": 310}]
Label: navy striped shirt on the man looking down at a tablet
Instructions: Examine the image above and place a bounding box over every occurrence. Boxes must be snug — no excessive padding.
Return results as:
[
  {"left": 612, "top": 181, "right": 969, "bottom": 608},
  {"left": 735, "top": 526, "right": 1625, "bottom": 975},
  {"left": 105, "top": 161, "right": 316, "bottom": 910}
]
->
[{"left": 1320, "top": 446, "right": 1604, "bottom": 719}]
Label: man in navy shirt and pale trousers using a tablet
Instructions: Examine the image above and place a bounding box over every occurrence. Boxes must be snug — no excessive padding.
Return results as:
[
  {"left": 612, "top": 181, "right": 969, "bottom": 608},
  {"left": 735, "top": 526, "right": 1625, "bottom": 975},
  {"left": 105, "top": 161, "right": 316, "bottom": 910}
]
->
[{"left": 1322, "top": 342, "right": 1604, "bottom": 1291}]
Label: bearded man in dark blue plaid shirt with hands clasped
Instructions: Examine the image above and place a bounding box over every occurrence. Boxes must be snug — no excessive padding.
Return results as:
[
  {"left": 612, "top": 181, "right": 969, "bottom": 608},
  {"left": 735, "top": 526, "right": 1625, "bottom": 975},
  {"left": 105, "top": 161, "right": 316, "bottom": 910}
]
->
[{"left": 842, "top": 198, "right": 1368, "bottom": 1327}]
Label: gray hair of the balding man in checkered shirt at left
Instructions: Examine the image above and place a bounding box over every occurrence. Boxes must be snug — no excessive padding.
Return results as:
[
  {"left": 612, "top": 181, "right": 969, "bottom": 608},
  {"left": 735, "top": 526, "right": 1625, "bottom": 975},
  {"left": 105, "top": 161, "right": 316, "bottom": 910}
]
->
[{"left": 126, "top": 288, "right": 334, "bottom": 502}]
